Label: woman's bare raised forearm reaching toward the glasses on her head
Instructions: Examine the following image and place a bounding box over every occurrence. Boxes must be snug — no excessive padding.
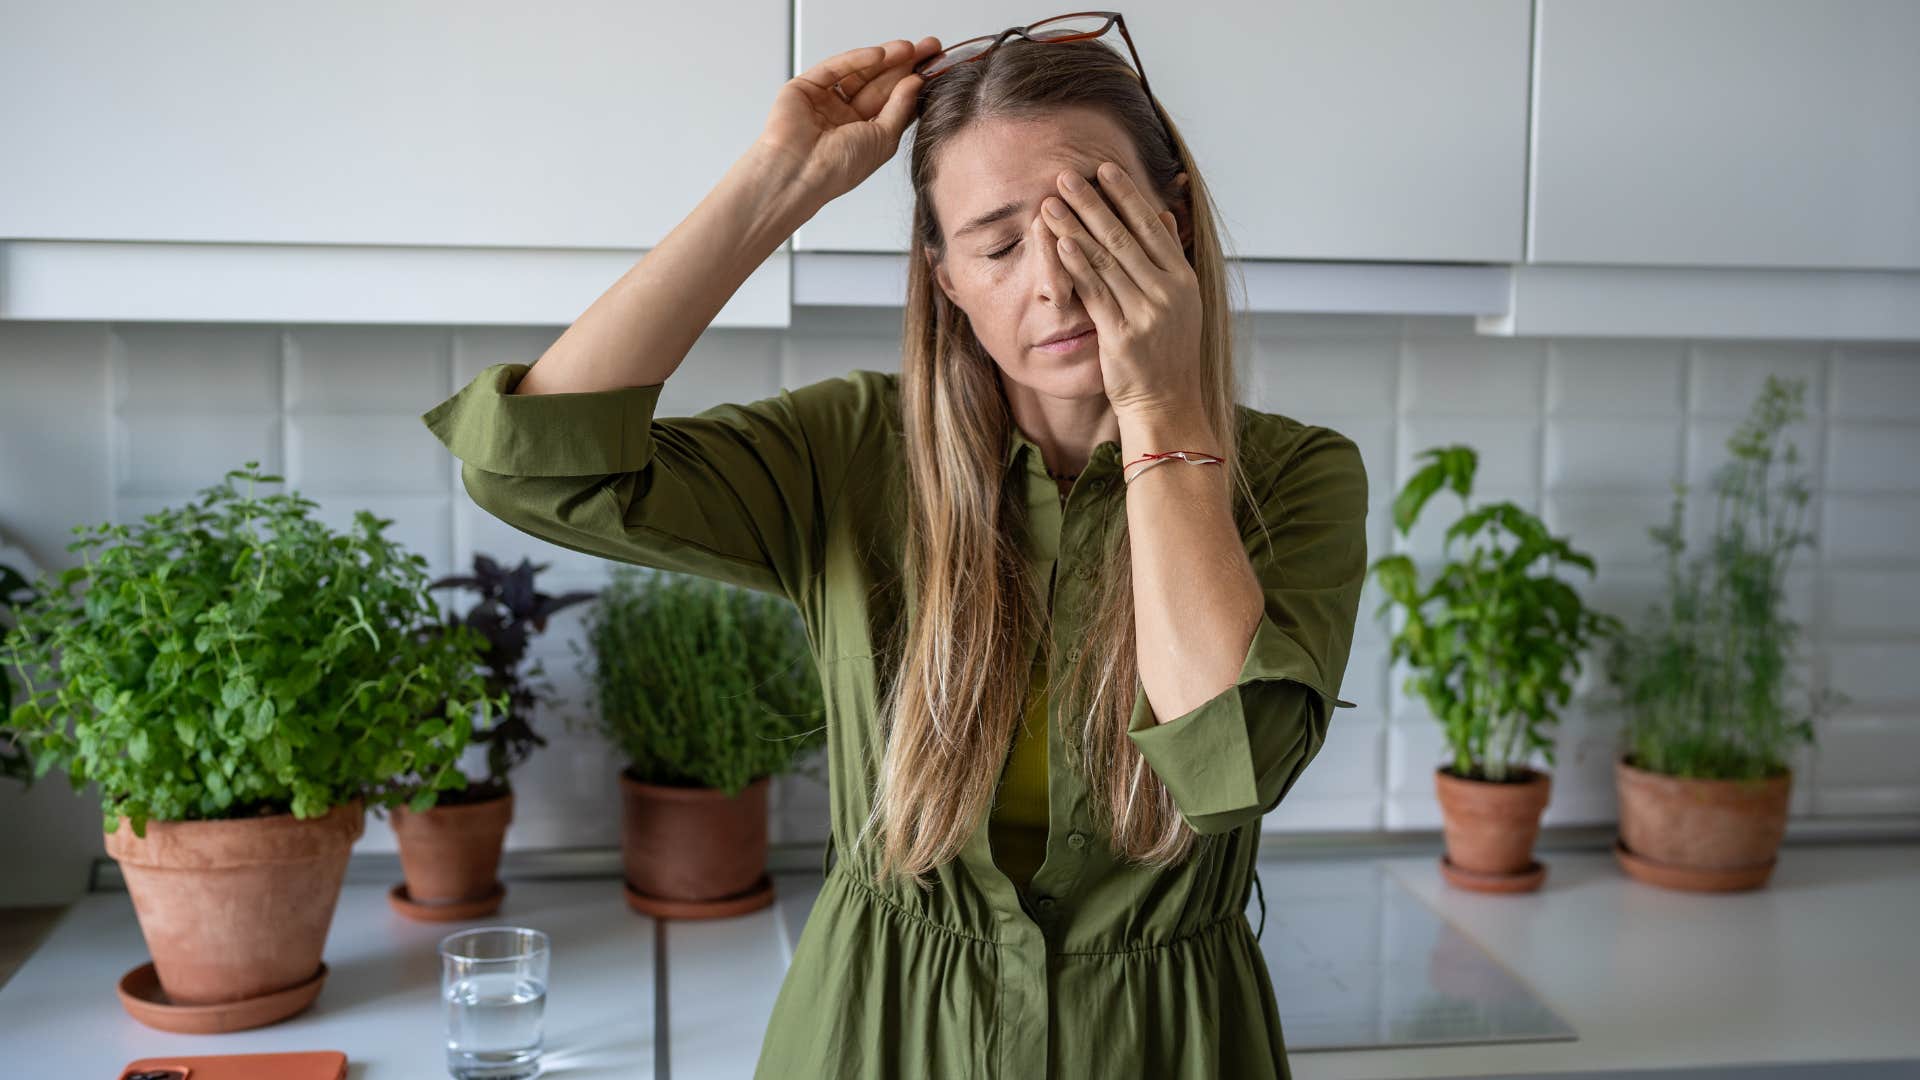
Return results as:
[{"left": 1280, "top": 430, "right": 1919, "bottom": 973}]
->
[{"left": 513, "top": 146, "right": 818, "bottom": 394}]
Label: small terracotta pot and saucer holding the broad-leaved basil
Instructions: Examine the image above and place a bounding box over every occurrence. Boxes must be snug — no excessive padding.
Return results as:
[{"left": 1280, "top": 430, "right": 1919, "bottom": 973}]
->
[{"left": 1434, "top": 765, "right": 1553, "bottom": 892}]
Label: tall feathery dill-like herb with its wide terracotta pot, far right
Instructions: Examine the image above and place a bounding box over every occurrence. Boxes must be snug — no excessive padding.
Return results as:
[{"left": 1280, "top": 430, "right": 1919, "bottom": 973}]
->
[{"left": 1607, "top": 375, "right": 1847, "bottom": 892}]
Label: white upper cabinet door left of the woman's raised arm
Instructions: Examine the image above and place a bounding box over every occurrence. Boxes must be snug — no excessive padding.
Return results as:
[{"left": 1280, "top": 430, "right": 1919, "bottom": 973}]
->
[{"left": 0, "top": 0, "right": 791, "bottom": 247}]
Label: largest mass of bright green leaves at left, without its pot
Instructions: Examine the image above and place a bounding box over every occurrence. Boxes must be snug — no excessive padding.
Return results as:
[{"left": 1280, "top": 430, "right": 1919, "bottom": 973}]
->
[{"left": 0, "top": 461, "right": 501, "bottom": 836}]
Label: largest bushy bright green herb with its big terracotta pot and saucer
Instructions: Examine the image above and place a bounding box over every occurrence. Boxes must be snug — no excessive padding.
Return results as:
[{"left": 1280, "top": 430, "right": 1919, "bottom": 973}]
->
[{"left": 0, "top": 461, "right": 497, "bottom": 1032}]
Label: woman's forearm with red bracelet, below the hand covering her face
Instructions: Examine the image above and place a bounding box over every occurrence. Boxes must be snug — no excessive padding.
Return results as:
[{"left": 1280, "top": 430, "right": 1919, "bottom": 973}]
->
[{"left": 1119, "top": 403, "right": 1265, "bottom": 723}]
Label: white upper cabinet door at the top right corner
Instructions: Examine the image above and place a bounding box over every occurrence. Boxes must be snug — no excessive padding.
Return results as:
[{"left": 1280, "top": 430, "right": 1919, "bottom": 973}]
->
[{"left": 1528, "top": 0, "right": 1920, "bottom": 269}]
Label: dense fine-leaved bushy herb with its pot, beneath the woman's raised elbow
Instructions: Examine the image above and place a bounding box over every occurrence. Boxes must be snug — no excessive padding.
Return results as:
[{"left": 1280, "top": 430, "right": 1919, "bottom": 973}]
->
[{"left": 576, "top": 565, "right": 826, "bottom": 919}]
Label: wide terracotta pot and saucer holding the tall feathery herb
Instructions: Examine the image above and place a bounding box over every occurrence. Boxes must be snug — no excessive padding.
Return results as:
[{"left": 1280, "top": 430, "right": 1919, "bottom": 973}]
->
[{"left": 1613, "top": 755, "right": 1793, "bottom": 892}]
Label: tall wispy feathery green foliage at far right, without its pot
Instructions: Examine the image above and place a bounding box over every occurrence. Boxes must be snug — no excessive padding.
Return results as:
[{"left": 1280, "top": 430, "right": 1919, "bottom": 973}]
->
[{"left": 1607, "top": 375, "right": 1849, "bottom": 780}]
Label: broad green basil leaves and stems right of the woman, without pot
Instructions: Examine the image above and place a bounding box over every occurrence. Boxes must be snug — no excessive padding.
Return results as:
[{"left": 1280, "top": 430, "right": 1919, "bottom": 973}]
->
[{"left": 1371, "top": 444, "right": 1620, "bottom": 782}]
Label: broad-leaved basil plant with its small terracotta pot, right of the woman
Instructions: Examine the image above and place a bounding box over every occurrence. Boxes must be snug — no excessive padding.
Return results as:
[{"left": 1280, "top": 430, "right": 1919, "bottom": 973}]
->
[{"left": 1371, "top": 444, "right": 1620, "bottom": 892}]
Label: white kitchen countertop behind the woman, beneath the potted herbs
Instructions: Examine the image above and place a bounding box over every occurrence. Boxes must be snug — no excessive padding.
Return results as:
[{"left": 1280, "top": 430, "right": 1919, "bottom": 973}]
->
[{"left": 0, "top": 844, "right": 1920, "bottom": 1080}]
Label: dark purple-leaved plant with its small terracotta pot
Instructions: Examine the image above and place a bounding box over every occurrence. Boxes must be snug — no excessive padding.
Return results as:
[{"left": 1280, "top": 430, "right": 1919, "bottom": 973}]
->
[{"left": 388, "top": 553, "right": 597, "bottom": 922}]
